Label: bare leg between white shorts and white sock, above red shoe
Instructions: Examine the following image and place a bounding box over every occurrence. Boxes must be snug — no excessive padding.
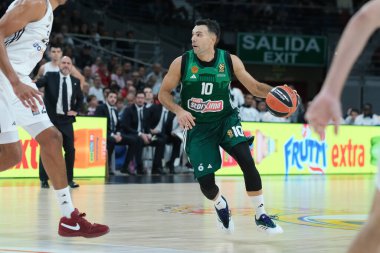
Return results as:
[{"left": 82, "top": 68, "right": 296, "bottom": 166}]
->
[{"left": 36, "top": 127, "right": 67, "bottom": 190}]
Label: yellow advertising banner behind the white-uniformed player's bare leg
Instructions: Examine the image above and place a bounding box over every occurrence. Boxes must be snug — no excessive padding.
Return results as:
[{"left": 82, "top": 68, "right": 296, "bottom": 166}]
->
[{"left": 0, "top": 117, "right": 107, "bottom": 178}]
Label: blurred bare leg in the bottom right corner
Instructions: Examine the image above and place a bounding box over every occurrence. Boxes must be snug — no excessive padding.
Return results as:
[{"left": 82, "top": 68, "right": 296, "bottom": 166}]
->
[{"left": 348, "top": 190, "right": 380, "bottom": 253}]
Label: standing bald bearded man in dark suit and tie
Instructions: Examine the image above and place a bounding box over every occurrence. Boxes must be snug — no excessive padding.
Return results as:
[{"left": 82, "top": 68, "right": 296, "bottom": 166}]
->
[{"left": 36, "top": 56, "right": 83, "bottom": 188}]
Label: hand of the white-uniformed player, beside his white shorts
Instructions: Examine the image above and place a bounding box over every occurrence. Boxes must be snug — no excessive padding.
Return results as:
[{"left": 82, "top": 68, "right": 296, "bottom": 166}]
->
[{"left": 13, "top": 81, "right": 44, "bottom": 112}]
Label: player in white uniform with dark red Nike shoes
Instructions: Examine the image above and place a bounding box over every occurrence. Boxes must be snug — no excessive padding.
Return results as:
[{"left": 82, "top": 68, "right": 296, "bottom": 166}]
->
[{"left": 0, "top": 0, "right": 109, "bottom": 237}]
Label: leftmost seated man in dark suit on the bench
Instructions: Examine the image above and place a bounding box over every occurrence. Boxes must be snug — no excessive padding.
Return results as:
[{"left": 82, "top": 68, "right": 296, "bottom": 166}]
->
[{"left": 95, "top": 90, "right": 143, "bottom": 174}]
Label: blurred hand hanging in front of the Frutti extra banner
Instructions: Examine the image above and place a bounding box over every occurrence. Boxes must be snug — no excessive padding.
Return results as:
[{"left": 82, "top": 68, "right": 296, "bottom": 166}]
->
[{"left": 305, "top": 91, "right": 342, "bottom": 138}]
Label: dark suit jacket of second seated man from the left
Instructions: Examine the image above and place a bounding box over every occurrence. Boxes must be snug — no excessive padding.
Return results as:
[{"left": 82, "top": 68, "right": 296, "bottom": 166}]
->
[{"left": 121, "top": 105, "right": 151, "bottom": 134}]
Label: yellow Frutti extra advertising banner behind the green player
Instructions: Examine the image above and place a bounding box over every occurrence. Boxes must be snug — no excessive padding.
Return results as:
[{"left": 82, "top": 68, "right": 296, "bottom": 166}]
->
[{"left": 217, "top": 122, "right": 380, "bottom": 175}]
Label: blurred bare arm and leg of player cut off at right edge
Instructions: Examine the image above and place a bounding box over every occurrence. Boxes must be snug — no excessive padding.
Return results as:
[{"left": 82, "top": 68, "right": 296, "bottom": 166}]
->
[{"left": 306, "top": 0, "right": 380, "bottom": 253}]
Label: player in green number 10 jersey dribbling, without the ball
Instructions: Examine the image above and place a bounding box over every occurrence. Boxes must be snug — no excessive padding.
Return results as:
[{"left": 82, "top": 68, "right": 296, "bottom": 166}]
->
[{"left": 158, "top": 19, "right": 282, "bottom": 234}]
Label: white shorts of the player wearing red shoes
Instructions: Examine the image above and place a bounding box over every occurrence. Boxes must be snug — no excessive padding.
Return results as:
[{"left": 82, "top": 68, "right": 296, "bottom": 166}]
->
[{"left": 0, "top": 72, "right": 53, "bottom": 144}]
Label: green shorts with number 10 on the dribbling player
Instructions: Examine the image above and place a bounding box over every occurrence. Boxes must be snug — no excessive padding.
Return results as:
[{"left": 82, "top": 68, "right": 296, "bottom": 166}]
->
[{"left": 185, "top": 113, "right": 253, "bottom": 178}]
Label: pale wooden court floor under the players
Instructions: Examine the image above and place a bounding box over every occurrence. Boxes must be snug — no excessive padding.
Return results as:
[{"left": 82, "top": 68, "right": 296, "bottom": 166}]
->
[{"left": 0, "top": 175, "right": 375, "bottom": 253}]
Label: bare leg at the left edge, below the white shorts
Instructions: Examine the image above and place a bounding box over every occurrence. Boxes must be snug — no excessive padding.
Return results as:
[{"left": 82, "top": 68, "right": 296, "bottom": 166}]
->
[{"left": 0, "top": 141, "right": 22, "bottom": 171}]
